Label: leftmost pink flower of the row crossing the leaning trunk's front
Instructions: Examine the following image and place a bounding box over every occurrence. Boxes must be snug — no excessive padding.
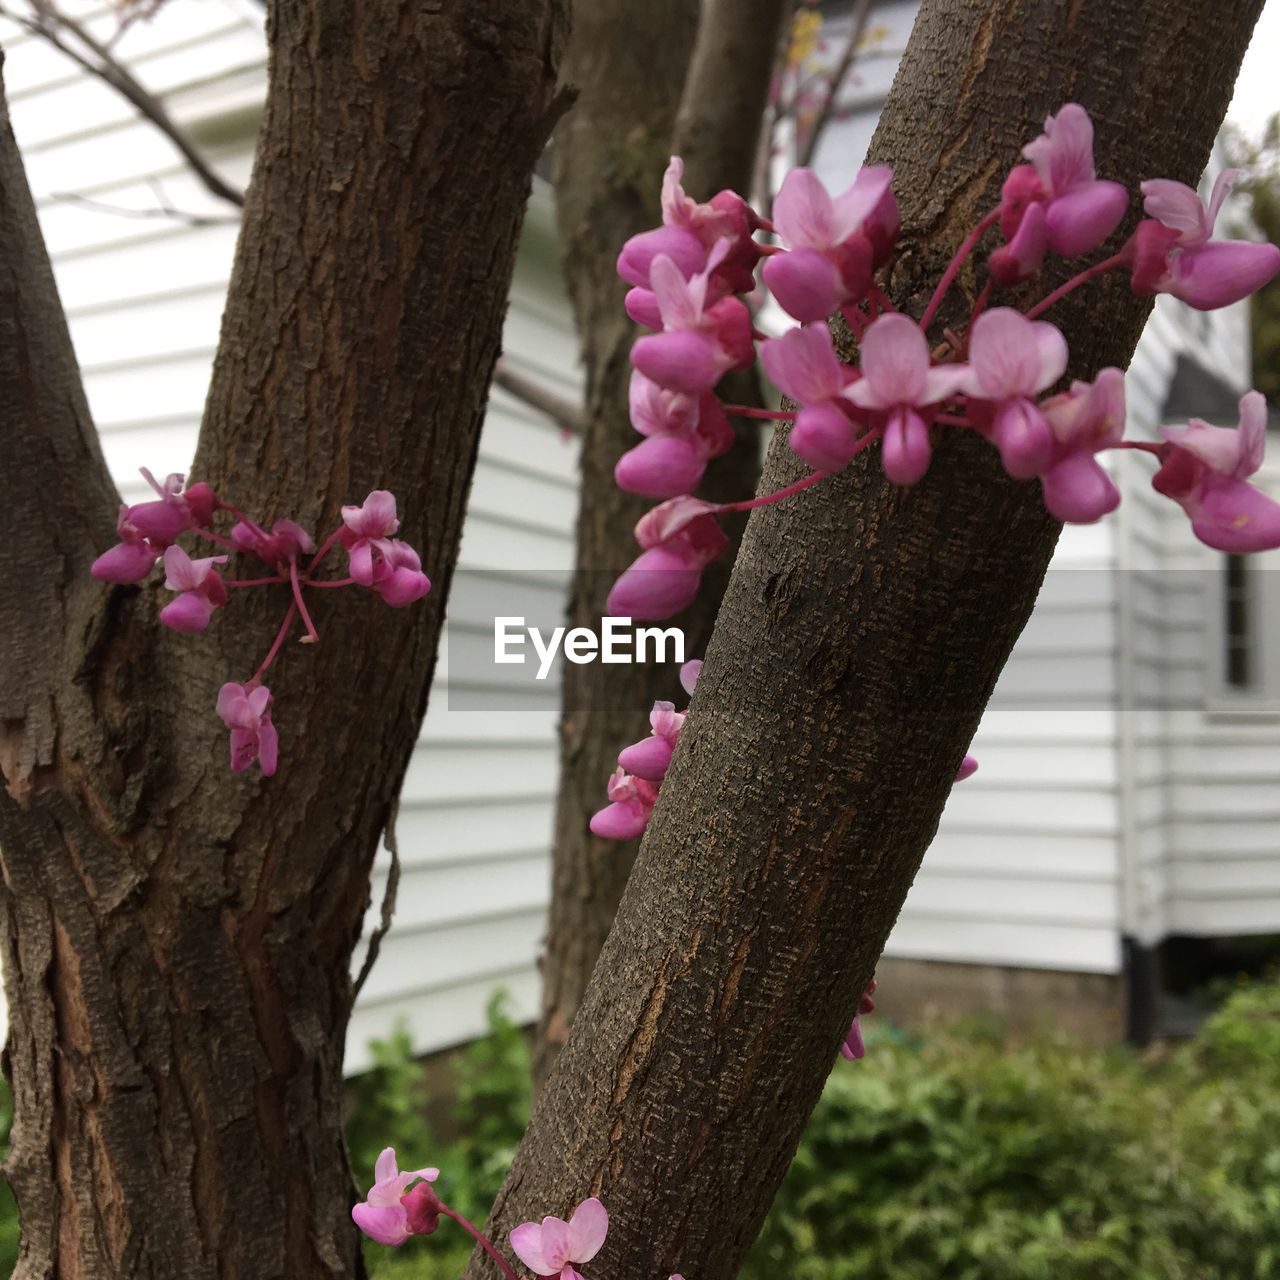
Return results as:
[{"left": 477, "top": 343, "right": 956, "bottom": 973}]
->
[{"left": 760, "top": 324, "right": 867, "bottom": 471}]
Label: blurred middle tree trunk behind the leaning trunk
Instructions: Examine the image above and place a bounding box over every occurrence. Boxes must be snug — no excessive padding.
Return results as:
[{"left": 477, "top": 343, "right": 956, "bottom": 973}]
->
[{"left": 534, "top": 0, "right": 788, "bottom": 1082}]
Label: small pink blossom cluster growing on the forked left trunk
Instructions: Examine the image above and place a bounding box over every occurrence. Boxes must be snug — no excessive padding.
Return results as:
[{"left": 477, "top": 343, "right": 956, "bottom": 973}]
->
[{"left": 90, "top": 483, "right": 431, "bottom": 777}]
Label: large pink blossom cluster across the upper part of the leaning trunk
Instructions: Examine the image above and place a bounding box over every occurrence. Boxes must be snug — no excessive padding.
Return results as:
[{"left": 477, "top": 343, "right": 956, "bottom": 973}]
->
[{"left": 609, "top": 102, "right": 1280, "bottom": 624}]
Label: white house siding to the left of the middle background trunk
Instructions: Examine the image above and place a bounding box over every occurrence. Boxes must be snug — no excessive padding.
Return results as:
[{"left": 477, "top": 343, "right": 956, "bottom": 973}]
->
[{"left": 0, "top": 0, "right": 579, "bottom": 1070}]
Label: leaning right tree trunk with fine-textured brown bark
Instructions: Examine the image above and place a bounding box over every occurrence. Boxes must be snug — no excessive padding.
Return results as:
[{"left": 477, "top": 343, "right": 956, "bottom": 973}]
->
[{"left": 468, "top": 0, "right": 1260, "bottom": 1280}]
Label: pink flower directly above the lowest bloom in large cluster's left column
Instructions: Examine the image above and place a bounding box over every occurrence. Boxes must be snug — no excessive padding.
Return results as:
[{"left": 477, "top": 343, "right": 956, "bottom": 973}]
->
[{"left": 613, "top": 371, "right": 733, "bottom": 498}]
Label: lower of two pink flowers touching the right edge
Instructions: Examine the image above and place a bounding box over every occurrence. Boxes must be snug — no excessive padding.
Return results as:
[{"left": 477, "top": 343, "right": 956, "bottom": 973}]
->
[{"left": 1152, "top": 392, "right": 1280, "bottom": 553}]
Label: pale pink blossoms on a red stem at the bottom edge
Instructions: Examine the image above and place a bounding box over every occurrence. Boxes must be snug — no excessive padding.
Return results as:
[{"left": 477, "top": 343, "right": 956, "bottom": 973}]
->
[{"left": 351, "top": 1162, "right": 684, "bottom": 1280}]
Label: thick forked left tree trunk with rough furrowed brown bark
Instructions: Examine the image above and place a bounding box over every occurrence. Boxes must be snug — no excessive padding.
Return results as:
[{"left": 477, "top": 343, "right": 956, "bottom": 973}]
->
[{"left": 0, "top": 0, "right": 566, "bottom": 1280}]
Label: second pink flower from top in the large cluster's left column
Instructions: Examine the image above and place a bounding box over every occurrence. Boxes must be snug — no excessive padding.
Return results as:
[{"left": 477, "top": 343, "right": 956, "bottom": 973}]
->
[{"left": 631, "top": 241, "right": 755, "bottom": 396}]
